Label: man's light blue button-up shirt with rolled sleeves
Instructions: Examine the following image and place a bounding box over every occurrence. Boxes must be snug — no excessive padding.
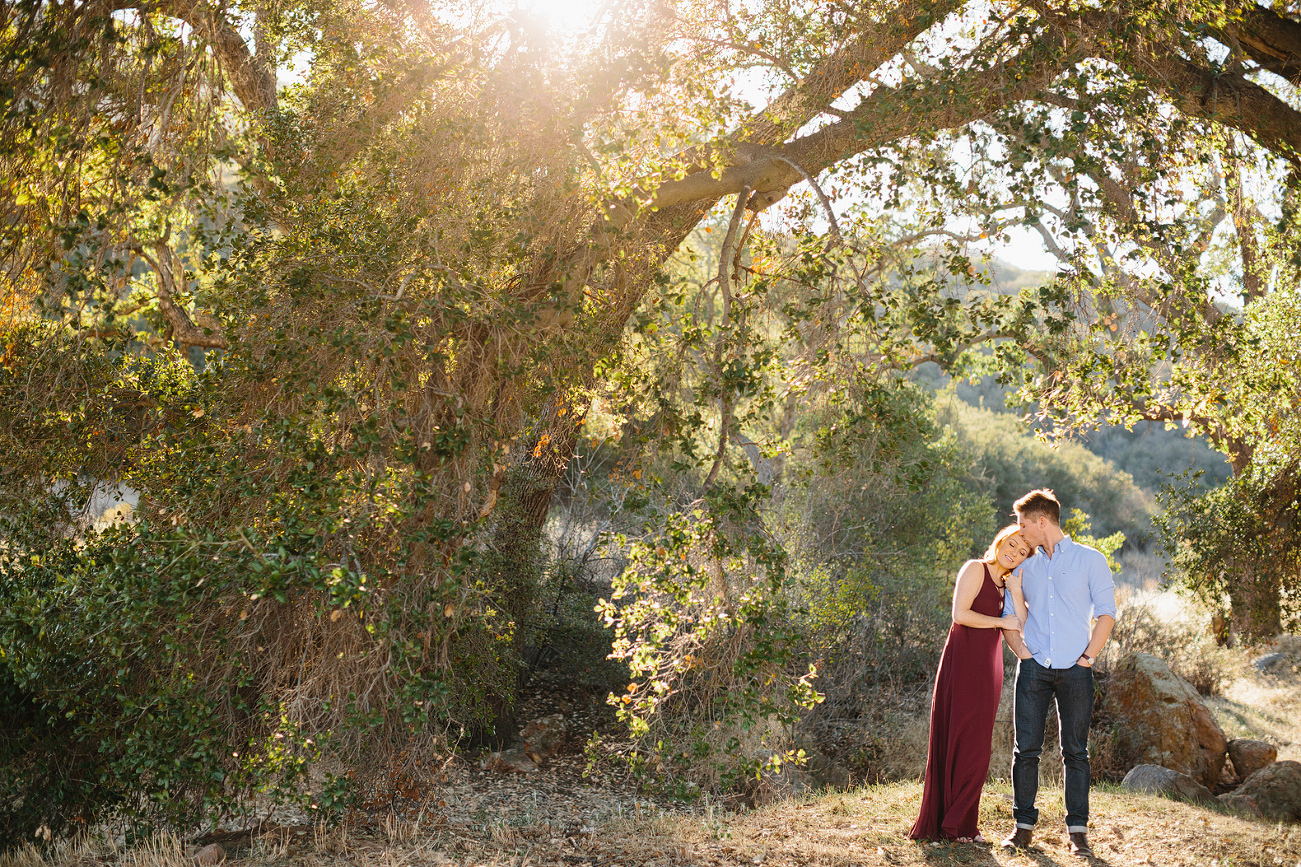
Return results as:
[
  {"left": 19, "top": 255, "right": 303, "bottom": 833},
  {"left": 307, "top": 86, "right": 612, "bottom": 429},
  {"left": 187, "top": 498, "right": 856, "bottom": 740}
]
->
[{"left": 1003, "top": 536, "right": 1116, "bottom": 668}]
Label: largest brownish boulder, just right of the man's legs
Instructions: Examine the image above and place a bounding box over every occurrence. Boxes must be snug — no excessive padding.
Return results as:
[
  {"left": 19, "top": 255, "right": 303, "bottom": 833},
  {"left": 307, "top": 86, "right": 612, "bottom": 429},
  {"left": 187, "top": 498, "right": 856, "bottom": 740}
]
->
[{"left": 1105, "top": 654, "right": 1228, "bottom": 788}]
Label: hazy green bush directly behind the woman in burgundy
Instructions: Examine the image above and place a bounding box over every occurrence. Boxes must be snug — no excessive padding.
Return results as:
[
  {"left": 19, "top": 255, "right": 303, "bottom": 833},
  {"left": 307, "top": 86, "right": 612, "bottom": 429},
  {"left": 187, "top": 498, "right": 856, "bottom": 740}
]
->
[{"left": 781, "top": 384, "right": 995, "bottom": 780}]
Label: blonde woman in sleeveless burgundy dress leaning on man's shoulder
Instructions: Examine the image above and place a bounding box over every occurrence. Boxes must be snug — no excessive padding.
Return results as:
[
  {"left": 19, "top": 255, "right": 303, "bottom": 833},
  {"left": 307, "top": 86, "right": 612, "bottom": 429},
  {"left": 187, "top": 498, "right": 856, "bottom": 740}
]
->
[{"left": 908, "top": 523, "right": 1030, "bottom": 842}]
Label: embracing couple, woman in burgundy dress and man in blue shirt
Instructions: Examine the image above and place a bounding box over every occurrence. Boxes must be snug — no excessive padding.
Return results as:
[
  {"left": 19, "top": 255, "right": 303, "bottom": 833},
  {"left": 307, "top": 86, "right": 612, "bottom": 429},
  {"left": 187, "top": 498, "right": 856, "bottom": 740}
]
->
[{"left": 909, "top": 491, "right": 1116, "bottom": 858}]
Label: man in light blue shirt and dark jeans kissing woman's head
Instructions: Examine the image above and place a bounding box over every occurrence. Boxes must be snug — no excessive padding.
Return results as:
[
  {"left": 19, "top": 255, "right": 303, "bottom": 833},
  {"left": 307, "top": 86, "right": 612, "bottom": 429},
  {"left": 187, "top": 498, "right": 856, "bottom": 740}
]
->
[{"left": 1003, "top": 489, "right": 1116, "bottom": 858}]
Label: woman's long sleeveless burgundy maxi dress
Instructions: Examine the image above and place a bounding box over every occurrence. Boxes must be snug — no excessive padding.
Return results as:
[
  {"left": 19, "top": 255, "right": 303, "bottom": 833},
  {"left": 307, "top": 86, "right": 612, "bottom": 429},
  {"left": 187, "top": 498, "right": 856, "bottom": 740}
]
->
[{"left": 908, "top": 564, "right": 1003, "bottom": 840}]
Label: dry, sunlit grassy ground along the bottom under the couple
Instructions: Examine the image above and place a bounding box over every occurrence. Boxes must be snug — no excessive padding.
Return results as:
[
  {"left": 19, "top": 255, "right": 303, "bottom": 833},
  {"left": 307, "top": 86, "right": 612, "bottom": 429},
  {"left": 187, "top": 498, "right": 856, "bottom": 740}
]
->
[{"left": 0, "top": 782, "right": 1301, "bottom": 867}]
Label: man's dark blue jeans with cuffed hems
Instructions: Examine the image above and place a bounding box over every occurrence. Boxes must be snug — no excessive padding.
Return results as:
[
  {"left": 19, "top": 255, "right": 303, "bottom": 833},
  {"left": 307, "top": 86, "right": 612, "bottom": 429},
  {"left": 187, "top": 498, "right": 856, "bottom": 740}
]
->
[{"left": 1012, "top": 659, "right": 1093, "bottom": 832}]
